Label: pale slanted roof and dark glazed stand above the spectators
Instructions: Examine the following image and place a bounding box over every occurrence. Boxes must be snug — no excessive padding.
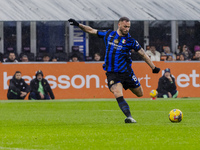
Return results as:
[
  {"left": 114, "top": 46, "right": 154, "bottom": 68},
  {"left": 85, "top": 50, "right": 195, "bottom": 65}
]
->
[{"left": 0, "top": 0, "right": 200, "bottom": 61}]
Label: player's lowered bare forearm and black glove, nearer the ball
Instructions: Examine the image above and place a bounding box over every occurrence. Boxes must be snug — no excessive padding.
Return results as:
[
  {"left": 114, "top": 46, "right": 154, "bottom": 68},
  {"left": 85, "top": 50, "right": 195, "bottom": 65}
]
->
[{"left": 138, "top": 48, "right": 160, "bottom": 73}]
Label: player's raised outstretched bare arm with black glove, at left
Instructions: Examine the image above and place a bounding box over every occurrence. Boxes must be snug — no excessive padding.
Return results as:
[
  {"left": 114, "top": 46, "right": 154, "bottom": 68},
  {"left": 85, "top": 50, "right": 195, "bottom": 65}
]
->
[{"left": 68, "top": 19, "right": 97, "bottom": 35}]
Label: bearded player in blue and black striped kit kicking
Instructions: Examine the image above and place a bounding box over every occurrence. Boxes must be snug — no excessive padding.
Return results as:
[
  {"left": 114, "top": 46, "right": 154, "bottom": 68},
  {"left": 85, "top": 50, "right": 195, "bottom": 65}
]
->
[{"left": 68, "top": 17, "right": 160, "bottom": 123}]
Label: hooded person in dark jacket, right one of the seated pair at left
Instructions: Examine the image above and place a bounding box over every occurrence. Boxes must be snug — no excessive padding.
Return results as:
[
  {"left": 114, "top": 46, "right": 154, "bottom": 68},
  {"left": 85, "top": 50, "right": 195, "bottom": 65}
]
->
[{"left": 29, "top": 70, "right": 55, "bottom": 100}]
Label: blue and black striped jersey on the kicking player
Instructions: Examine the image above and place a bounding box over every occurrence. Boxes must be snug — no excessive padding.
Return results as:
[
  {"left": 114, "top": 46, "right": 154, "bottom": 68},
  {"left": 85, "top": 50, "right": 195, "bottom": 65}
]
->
[{"left": 97, "top": 30, "right": 141, "bottom": 73}]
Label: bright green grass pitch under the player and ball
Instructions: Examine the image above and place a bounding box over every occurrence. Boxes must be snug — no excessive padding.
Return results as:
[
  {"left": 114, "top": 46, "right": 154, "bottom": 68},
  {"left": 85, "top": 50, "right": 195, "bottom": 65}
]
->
[{"left": 0, "top": 98, "right": 200, "bottom": 150}]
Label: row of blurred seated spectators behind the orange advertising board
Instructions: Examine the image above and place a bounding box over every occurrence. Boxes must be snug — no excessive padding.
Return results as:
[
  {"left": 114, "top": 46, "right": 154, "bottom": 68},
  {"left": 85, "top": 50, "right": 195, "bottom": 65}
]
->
[{"left": 0, "top": 45, "right": 200, "bottom": 63}]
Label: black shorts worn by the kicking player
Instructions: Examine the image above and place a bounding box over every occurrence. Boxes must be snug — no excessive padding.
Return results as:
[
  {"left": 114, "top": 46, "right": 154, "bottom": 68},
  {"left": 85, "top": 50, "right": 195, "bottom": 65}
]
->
[{"left": 106, "top": 72, "right": 140, "bottom": 90}]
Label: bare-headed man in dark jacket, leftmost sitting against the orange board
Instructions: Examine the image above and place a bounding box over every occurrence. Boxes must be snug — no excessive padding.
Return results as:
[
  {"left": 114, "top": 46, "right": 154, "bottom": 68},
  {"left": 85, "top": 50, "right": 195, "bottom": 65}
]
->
[{"left": 7, "top": 71, "right": 30, "bottom": 99}]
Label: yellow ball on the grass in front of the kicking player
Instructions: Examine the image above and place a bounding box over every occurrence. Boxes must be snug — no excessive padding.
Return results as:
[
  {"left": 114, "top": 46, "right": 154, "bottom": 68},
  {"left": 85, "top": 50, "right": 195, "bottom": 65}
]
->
[{"left": 169, "top": 109, "right": 183, "bottom": 122}]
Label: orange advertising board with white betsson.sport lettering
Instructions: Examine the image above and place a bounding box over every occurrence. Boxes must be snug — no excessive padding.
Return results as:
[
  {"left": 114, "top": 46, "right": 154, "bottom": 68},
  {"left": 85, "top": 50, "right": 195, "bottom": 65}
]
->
[{"left": 0, "top": 62, "right": 200, "bottom": 100}]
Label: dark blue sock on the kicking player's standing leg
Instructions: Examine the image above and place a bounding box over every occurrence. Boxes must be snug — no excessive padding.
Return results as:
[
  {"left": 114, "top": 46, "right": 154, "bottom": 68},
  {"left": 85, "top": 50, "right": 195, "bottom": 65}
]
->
[{"left": 116, "top": 96, "right": 131, "bottom": 117}]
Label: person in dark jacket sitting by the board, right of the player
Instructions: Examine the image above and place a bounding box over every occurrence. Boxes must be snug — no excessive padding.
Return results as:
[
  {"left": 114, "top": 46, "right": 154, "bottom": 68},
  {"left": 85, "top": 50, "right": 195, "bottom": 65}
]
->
[{"left": 157, "top": 68, "right": 178, "bottom": 98}]
